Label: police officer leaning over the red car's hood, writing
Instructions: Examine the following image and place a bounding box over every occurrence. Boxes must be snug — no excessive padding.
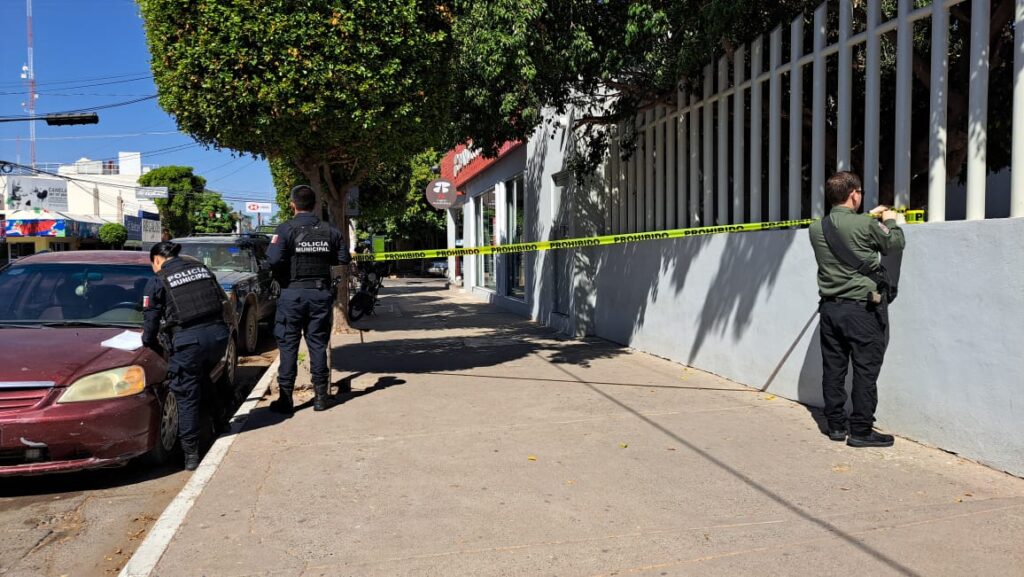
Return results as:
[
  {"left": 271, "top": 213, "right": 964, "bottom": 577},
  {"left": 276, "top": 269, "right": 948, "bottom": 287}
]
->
[{"left": 142, "top": 242, "right": 229, "bottom": 470}]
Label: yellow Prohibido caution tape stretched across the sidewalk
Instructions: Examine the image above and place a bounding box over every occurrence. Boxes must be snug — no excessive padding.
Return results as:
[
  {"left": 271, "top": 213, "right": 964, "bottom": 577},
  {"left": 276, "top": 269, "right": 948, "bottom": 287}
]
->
[{"left": 352, "top": 210, "right": 924, "bottom": 261}]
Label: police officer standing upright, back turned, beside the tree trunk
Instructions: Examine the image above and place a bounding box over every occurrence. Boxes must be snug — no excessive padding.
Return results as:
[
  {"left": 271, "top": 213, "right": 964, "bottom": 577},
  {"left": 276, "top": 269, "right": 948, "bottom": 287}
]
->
[{"left": 267, "top": 184, "right": 351, "bottom": 414}]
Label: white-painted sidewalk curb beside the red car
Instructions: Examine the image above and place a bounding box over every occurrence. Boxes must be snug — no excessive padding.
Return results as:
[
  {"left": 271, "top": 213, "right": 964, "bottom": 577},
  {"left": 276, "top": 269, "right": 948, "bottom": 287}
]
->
[{"left": 118, "top": 357, "right": 281, "bottom": 577}]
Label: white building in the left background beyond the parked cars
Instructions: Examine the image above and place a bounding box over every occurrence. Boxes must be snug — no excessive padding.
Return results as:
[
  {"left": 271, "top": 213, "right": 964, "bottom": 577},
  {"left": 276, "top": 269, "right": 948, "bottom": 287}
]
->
[{"left": 56, "top": 153, "right": 157, "bottom": 222}]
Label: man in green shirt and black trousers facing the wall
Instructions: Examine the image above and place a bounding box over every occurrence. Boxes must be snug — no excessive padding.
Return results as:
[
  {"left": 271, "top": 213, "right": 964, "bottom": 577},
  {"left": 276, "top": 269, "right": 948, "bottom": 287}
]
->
[{"left": 810, "top": 172, "right": 906, "bottom": 447}]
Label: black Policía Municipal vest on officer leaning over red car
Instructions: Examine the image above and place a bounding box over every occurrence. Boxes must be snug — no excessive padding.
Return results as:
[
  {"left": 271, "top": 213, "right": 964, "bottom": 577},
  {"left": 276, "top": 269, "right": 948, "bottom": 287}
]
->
[{"left": 157, "top": 258, "right": 224, "bottom": 326}]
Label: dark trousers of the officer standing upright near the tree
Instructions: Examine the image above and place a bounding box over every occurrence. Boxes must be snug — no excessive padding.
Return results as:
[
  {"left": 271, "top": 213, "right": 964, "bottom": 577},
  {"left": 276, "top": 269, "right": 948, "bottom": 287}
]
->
[{"left": 273, "top": 288, "right": 334, "bottom": 391}]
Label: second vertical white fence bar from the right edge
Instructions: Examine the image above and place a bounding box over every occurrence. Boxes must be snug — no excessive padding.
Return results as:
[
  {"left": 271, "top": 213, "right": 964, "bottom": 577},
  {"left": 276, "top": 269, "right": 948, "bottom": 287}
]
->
[{"left": 967, "top": 0, "right": 990, "bottom": 220}]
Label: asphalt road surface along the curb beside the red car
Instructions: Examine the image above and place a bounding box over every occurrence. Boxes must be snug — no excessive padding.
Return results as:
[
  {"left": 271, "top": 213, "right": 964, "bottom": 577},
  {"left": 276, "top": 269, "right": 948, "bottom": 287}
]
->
[{"left": 0, "top": 339, "right": 276, "bottom": 577}]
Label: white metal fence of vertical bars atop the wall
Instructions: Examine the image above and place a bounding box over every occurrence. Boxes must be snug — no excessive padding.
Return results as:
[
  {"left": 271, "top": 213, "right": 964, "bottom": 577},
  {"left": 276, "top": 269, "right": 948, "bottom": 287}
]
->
[{"left": 605, "top": 0, "right": 1024, "bottom": 233}]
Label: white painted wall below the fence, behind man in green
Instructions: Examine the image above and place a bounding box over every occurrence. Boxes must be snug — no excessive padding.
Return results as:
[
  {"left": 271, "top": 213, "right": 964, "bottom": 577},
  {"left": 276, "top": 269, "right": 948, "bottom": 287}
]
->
[{"left": 569, "top": 218, "right": 1024, "bottom": 476}]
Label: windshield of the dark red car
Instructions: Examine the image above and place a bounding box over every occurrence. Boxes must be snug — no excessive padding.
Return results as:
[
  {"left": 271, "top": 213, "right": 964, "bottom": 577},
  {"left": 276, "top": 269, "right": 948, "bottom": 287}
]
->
[{"left": 0, "top": 263, "right": 153, "bottom": 328}]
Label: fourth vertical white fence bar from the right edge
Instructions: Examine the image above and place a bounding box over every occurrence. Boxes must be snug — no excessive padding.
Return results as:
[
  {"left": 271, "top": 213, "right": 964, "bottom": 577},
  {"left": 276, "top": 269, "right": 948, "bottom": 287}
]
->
[{"left": 893, "top": 0, "right": 913, "bottom": 208}]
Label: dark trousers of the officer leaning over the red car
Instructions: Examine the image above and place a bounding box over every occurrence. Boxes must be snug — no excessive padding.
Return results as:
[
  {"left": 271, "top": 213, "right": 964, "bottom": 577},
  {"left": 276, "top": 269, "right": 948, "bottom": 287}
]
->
[{"left": 167, "top": 323, "right": 230, "bottom": 449}]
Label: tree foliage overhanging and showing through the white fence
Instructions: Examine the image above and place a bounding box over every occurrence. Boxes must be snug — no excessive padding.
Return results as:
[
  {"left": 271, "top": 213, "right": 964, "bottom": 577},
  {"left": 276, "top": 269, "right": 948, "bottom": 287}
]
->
[{"left": 454, "top": 0, "right": 1014, "bottom": 208}]
